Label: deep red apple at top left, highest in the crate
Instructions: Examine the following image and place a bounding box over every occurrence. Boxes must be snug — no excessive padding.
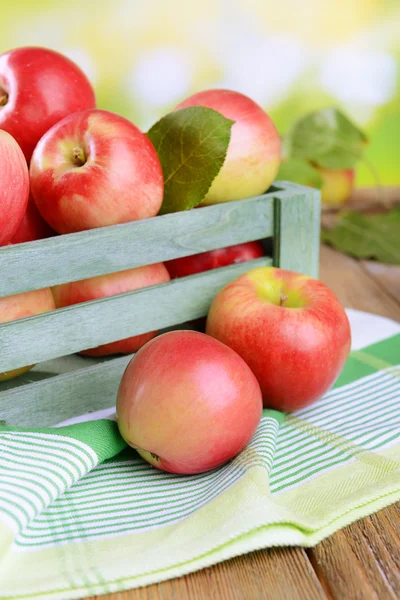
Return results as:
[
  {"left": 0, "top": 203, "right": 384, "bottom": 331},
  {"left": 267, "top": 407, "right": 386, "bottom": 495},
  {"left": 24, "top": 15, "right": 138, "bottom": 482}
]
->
[{"left": 0, "top": 47, "right": 96, "bottom": 162}]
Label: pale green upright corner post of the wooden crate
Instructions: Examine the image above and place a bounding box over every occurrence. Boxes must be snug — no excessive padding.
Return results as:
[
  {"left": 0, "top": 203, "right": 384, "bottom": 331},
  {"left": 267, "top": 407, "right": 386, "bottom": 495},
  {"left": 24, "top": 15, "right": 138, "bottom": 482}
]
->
[{"left": 274, "top": 188, "right": 321, "bottom": 277}]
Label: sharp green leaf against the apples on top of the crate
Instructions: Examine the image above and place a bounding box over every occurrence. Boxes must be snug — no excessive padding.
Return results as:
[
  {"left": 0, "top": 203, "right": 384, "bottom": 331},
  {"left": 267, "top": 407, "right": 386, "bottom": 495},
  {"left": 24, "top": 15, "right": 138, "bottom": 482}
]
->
[{"left": 147, "top": 106, "right": 234, "bottom": 214}]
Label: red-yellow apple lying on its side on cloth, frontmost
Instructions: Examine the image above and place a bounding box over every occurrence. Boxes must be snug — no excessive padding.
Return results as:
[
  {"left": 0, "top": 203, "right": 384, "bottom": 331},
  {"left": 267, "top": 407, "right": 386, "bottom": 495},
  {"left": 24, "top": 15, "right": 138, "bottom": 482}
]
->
[{"left": 117, "top": 331, "right": 262, "bottom": 474}]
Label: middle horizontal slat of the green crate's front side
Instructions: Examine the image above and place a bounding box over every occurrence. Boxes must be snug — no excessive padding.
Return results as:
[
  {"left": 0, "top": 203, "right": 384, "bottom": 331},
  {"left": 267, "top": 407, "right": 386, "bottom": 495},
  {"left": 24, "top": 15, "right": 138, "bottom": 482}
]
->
[{"left": 0, "top": 257, "right": 271, "bottom": 372}]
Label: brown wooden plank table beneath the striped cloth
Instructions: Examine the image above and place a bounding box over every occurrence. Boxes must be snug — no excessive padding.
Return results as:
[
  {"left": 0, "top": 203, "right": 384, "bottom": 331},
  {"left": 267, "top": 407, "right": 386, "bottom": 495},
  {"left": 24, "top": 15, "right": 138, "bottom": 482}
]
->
[{"left": 91, "top": 246, "right": 400, "bottom": 600}]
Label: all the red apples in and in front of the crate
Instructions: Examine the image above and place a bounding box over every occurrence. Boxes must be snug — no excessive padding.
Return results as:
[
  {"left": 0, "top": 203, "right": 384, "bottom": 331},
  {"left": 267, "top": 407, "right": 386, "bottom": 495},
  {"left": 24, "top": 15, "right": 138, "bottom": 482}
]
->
[{"left": 0, "top": 48, "right": 350, "bottom": 473}]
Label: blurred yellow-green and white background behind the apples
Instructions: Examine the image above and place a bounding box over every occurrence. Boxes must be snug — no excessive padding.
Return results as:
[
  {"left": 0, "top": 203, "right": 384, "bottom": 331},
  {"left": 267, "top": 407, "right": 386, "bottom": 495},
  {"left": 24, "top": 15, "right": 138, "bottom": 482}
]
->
[{"left": 0, "top": 0, "right": 400, "bottom": 186}]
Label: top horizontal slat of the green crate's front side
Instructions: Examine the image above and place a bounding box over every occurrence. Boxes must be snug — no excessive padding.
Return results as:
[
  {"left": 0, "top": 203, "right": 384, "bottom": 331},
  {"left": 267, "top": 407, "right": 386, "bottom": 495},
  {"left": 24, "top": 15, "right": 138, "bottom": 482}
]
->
[{"left": 0, "top": 191, "right": 278, "bottom": 297}]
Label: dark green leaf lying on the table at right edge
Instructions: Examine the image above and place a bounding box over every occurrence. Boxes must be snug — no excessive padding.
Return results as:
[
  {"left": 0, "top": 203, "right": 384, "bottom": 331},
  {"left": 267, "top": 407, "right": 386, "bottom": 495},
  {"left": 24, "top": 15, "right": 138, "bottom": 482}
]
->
[{"left": 321, "top": 207, "right": 400, "bottom": 265}]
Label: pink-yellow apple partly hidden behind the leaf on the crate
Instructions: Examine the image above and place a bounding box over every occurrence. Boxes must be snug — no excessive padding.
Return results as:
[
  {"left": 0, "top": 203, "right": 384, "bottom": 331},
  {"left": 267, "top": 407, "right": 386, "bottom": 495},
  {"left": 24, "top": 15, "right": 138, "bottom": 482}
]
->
[{"left": 177, "top": 89, "right": 281, "bottom": 205}]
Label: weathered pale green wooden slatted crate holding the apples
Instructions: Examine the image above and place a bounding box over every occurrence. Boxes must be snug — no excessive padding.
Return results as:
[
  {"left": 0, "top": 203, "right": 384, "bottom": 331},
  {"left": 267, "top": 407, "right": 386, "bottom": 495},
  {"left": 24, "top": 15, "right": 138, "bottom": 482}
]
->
[{"left": 0, "top": 182, "right": 320, "bottom": 427}]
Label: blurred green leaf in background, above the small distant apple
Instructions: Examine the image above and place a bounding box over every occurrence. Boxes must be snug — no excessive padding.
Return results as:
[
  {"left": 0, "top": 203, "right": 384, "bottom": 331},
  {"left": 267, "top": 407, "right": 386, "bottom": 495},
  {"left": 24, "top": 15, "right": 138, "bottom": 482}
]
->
[{"left": 284, "top": 108, "right": 368, "bottom": 169}]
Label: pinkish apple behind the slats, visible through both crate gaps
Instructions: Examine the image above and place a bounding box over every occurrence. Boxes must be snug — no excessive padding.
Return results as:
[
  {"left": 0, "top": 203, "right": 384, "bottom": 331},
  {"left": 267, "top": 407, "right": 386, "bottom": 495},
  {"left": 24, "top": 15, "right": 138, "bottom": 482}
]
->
[{"left": 53, "top": 263, "right": 170, "bottom": 356}]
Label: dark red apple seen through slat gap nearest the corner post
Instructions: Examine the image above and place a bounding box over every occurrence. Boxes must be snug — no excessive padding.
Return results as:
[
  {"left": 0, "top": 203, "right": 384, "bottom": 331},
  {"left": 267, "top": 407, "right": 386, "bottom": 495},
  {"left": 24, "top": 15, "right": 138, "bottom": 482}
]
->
[{"left": 165, "top": 242, "right": 264, "bottom": 278}]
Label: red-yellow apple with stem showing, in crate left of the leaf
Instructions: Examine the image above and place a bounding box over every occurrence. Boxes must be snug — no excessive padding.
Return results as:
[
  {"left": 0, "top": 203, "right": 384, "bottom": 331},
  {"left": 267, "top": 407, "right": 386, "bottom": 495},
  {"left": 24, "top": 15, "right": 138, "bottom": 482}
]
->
[{"left": 30, "top": 109, "right": 164, "bottom": 233}]
